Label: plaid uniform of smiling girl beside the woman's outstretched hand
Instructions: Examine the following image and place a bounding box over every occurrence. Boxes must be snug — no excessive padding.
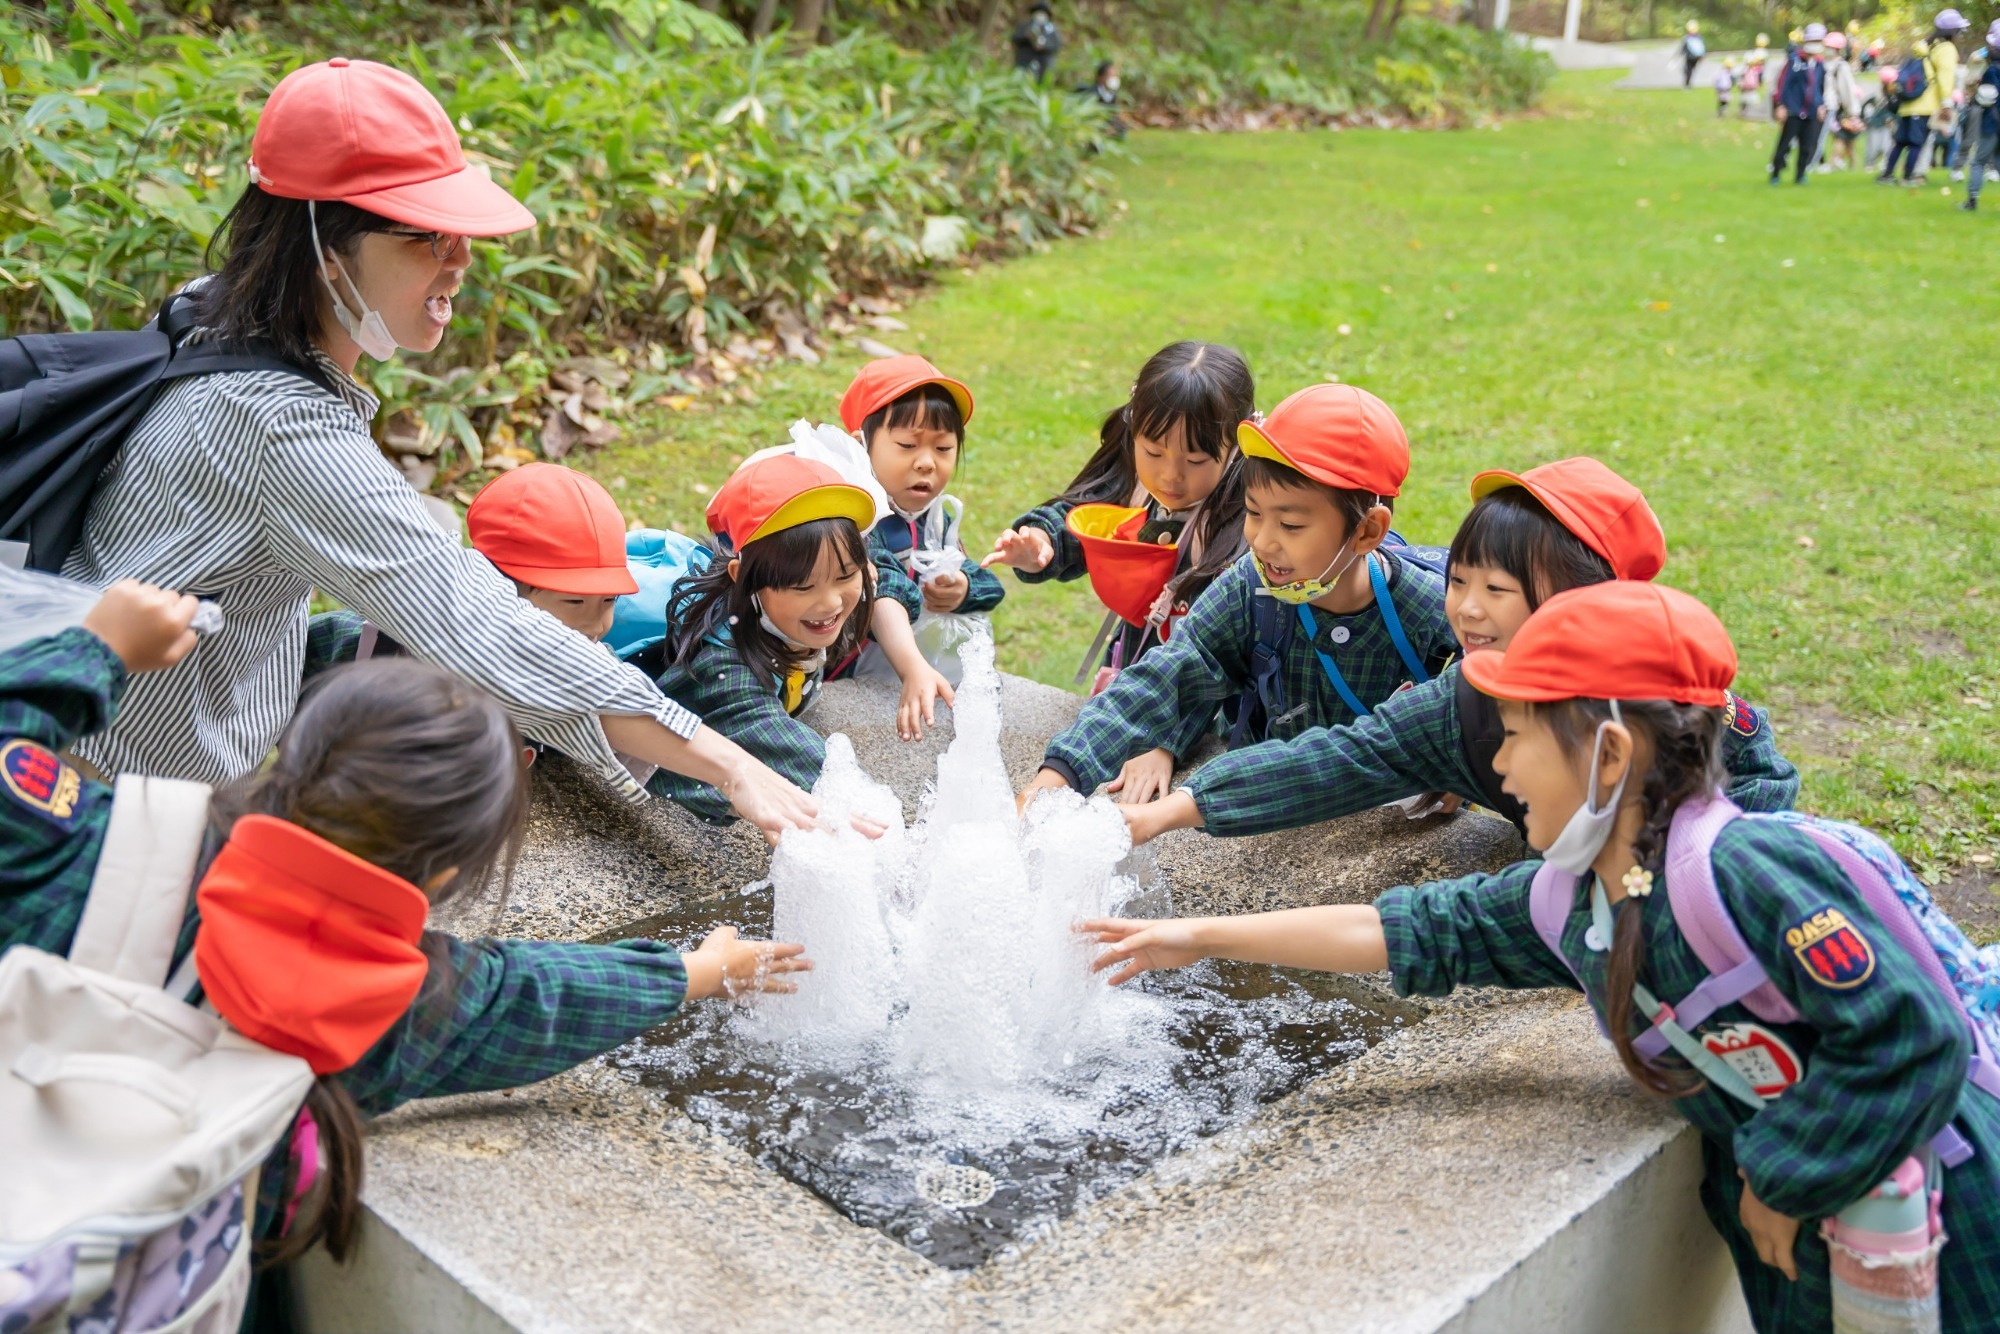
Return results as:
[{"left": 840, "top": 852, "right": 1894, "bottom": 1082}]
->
[{"left": 646, "top": 636, "right": 826, "bottom": 824}]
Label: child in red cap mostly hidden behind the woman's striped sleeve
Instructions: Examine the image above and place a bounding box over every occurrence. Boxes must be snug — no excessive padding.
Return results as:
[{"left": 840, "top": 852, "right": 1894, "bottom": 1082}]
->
[{"left": 306, "top": 464, "right": 638, "bottom": 678}]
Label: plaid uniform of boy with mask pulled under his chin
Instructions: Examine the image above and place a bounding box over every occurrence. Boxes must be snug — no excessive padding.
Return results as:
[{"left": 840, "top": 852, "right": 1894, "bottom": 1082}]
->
[{"left": 1042, "top": 552, "right": 1458, "bottom": 792}]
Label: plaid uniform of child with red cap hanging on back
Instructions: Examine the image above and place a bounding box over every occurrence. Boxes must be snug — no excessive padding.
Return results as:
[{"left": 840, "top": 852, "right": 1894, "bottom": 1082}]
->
[{"left": 0, "top": 630, "right": 688, "bottom": 1256}]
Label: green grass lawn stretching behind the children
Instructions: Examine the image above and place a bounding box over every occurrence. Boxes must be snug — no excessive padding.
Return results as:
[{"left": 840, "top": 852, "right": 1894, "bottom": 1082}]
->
[{"left": 586, "top": 74, "right": 2000, "bottom": 876}]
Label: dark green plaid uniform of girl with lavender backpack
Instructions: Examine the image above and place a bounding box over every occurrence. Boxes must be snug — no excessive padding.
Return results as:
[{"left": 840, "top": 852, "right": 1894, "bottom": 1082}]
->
[{"left": 1376, "top": 820, "right": 2000, "bottom": 1334}]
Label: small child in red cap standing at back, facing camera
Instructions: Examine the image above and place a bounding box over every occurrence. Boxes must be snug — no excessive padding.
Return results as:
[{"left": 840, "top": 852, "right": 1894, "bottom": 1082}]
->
[{"left": 840, "top": 356, "right": 1006, "bottom": 684}]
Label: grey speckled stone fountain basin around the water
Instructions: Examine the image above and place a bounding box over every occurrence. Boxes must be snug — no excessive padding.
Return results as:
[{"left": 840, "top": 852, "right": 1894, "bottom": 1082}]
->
[{"left": 298, "top": 678, "right": 1750, "bottom": 1334}]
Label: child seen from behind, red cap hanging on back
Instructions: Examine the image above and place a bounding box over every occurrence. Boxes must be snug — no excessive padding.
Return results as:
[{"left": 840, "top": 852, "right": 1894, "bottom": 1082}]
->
[{"left": 0, "top": 580, "right": 810, "bottom": 1330}]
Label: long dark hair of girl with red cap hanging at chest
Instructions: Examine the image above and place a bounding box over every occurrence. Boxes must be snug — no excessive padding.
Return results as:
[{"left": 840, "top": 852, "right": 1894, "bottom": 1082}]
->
[{"left": 1062, "top": 340, "right": 1256, "bottom": 602}]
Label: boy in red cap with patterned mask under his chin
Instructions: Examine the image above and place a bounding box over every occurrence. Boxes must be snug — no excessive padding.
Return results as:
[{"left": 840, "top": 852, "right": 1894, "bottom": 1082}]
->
[{"left": 1022, "top": 384, "right": 1456, "bottom": 804}]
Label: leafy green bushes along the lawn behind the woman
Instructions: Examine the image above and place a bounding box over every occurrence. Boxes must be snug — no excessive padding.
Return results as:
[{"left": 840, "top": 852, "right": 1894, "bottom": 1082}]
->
[{"left": 0, "top": 0, "right": 1540, "bottom": 488}]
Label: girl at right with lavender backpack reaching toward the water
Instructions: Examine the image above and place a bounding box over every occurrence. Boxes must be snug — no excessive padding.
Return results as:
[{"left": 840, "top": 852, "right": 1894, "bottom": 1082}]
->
[{"left": 1080, "top": 580, "right": 2000, "bottom": 1334}]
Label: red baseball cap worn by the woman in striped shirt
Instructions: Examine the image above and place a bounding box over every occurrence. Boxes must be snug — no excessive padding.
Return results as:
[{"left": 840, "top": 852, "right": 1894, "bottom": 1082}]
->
[{"left": 250, "top": 56, "right": 534, "bottom": 236}]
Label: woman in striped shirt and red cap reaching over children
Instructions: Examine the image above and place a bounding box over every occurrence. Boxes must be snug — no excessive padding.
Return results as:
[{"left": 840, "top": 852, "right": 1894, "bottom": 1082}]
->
[{"left": 64, "top": 60, "right": 814, "bottom": 836}]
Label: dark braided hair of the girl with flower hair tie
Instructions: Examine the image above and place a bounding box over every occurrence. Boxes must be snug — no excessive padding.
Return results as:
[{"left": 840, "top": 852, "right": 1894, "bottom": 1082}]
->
[{"left": 1528, "top": 700, "right": 1728, "bottom": 1098}]
